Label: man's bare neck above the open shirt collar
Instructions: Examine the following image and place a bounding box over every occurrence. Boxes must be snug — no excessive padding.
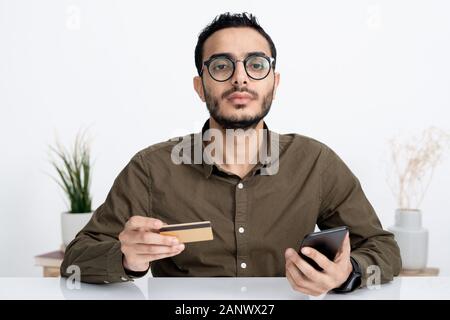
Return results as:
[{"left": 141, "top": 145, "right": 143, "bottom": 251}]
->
[{"left": 209, "top": 118, "right": 264, "bottom": 178}]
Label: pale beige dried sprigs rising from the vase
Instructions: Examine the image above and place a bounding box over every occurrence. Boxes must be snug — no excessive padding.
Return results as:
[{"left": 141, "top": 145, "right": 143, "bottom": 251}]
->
[{"left": 388, "top": 127, "right": 450, "bottom": 209}]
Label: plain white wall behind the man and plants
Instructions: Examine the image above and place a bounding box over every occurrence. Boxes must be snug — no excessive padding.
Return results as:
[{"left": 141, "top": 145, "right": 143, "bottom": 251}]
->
[{"left": 0, "top": 0, "right": 450, "bottom": 276}]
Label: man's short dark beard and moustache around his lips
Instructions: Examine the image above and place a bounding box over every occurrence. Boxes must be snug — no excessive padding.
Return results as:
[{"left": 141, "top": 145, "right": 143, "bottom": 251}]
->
[{"left": 203, "top": 84, "right": 275, "bottom": 130}]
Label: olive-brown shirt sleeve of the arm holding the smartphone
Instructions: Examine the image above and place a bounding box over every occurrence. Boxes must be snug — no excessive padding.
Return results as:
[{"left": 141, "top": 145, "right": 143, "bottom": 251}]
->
[{"left": 317, "top": 147, "right": 401, "bottom": 286}]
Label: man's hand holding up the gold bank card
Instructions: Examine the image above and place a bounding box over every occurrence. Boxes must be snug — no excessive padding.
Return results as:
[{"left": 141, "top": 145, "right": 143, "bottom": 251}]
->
[{"left": 119, "top": 216, "right": 184, "bottom": 272}]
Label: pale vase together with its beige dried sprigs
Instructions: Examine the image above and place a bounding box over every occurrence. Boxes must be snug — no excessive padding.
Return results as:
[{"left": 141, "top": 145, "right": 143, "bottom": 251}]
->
[{"left": 388, "top": 127, "right": 450, "bottom": 270}]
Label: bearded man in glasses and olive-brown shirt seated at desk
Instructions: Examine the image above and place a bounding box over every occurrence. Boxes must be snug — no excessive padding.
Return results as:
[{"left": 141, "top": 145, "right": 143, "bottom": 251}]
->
[{"left": 61, "top": 13, "right": 401, "bottom": 295}]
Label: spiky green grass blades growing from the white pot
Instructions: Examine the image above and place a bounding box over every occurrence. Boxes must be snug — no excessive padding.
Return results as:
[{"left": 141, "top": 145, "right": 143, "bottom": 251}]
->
[{"left": 50, "top": 132, "right": 92, "bottom": 213}]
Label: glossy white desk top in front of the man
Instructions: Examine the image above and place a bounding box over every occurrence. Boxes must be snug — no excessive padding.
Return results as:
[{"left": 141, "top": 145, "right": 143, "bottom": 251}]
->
[{"left": 0, "top": 277, "right": 450, "bottom": 300}]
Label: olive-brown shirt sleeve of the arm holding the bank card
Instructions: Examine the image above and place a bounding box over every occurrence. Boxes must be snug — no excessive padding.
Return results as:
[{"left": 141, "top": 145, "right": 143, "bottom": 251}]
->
[{"left": 60, "top": 153, "right": 150, "bottom": 283}]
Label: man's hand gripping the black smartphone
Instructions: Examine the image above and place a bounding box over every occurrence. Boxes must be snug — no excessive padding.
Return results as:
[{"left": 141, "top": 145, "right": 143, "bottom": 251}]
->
[{"left": 285, "top": 232, "right": 353, "bottom": 296}]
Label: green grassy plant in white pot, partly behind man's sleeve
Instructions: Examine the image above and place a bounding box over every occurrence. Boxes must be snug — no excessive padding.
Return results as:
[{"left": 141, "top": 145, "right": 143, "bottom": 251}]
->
[{"left": 50, "top": 133, "right": 92, "bottom": 249}]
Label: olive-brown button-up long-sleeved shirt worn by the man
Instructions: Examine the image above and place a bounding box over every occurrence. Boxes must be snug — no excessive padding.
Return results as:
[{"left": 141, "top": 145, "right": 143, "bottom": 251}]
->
[{"left": 61, "top": 121, "right": 401, "bottom": 286}]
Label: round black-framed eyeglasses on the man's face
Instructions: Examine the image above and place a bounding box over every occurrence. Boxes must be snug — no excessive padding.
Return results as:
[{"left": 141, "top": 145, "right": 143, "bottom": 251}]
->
[{"left": 201, "top": 54, "right": 275, "bottom": 82}]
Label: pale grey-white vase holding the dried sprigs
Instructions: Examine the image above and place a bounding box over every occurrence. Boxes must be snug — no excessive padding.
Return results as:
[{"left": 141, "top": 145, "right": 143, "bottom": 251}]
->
[{"left": 388, "top": 209, "right": 428, "bottom": 270}]
